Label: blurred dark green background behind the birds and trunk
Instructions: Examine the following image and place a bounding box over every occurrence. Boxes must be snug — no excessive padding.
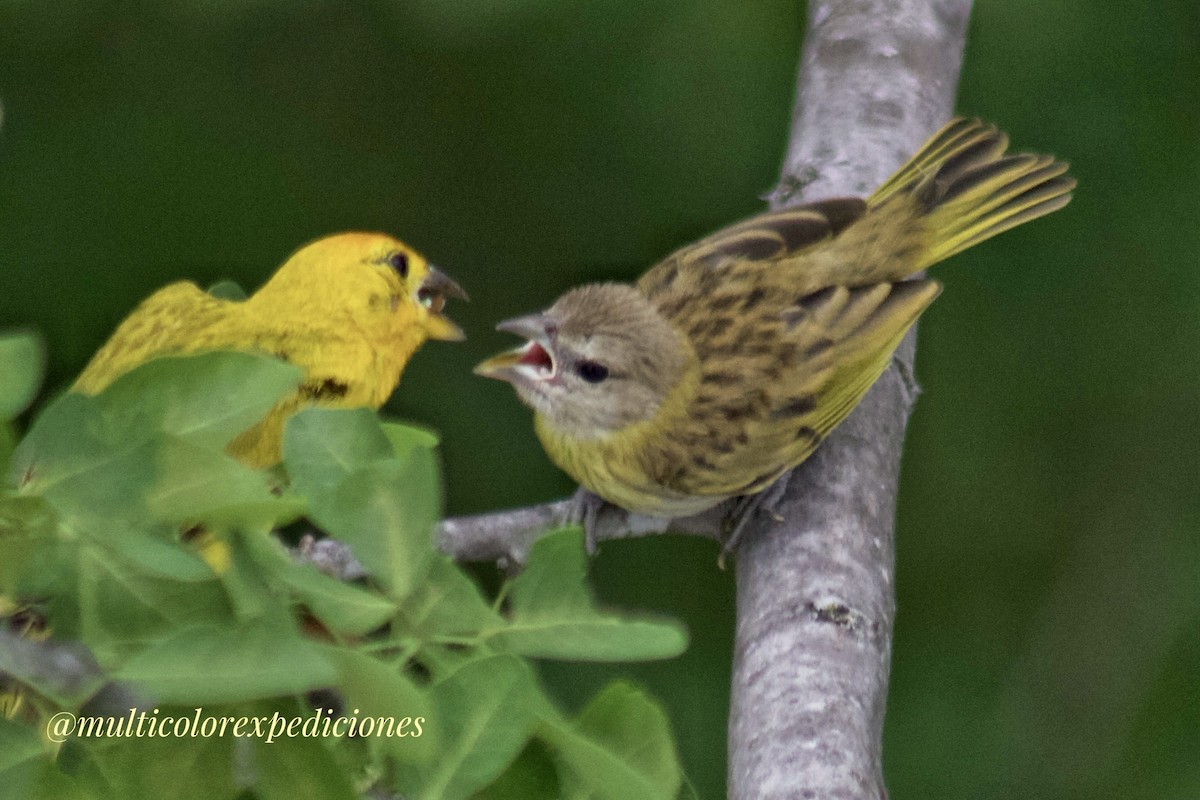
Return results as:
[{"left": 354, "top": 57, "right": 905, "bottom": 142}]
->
[{"left": 0, "top": 0, "right": 1200, "bottom": 800}]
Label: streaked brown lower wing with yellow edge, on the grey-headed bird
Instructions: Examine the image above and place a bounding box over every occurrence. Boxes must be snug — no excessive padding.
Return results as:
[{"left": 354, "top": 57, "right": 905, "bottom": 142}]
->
[{"left": 671, "top": 279, "right": 941, "bottom": 495}]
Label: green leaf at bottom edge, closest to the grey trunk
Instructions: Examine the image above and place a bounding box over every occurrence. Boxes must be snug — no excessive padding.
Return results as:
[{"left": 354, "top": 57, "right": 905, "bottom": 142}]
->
[{"left": 542, "top": 681, "right": 683, "bottom": 800}]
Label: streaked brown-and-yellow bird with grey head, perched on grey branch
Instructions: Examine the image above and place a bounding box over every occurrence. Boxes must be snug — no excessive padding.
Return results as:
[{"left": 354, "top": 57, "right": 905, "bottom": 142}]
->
[{"left": 475, "top": 119, "right": 1075, "bottom": 517}]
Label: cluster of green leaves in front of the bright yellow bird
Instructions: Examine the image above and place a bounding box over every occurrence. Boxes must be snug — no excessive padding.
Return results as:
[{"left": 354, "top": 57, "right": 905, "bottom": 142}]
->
[{"left": 0, "top": 333, "right": 685, "bottom": 800}]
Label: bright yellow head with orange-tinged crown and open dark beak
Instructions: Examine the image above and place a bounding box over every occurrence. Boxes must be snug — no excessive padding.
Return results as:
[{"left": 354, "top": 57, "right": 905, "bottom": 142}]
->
[{"left": 255, "top": 233, "right": 467, "bottom": 345}]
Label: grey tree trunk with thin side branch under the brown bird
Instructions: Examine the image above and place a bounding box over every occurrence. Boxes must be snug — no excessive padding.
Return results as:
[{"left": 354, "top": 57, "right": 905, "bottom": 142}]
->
[{"left": 438, "top": 0, "right": 971, "bottom": 800}]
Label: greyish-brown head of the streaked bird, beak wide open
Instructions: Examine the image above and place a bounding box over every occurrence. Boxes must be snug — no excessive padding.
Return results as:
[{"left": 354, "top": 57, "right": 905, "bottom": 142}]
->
[{"left": 475, "top": 283, "right": 690, "bottom": 439}]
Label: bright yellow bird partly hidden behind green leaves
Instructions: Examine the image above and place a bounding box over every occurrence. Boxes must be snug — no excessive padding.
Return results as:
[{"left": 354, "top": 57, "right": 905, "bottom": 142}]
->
[{"left": 72, "top": 233, "right": 467, "bottom": 467}]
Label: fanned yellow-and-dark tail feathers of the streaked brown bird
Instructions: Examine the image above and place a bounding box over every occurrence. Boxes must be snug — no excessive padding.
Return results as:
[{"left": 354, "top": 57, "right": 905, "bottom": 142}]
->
[{"left": 868, "top": 119, "right": 1075, "bottom": 270}]
